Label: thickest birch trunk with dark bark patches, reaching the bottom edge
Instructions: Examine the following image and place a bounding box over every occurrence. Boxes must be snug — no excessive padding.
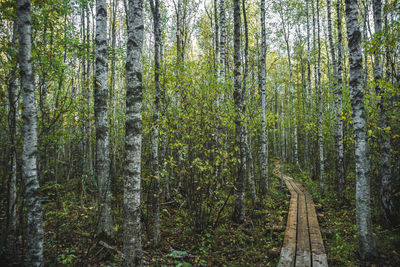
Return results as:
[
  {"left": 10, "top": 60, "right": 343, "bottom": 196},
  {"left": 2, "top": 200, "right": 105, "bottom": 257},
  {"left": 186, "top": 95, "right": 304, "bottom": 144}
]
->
[{"left": 123, "top": 0, "right": 144, "bottom": 266}]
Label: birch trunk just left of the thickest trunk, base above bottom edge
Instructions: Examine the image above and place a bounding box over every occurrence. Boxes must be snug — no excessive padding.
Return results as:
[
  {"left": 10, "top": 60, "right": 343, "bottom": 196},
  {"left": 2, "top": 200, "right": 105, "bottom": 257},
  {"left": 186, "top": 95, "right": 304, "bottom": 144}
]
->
[{"left": 94, "top": 0, "right": 114, "bottom": 237}]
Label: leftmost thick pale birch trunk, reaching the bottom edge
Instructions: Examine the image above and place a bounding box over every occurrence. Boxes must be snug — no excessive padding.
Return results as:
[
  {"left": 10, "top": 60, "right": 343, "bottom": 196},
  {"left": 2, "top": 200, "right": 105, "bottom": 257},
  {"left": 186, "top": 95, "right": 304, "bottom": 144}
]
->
[{"left": 17, "top": 0, "right": 44, "bottom": 266}]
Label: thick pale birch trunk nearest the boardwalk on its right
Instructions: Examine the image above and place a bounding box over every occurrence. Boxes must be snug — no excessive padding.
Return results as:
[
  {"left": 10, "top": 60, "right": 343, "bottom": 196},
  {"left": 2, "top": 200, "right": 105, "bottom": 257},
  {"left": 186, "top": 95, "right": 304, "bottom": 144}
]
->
[{"left": 346, "top": 0, "right": 377, "bottom": 259}]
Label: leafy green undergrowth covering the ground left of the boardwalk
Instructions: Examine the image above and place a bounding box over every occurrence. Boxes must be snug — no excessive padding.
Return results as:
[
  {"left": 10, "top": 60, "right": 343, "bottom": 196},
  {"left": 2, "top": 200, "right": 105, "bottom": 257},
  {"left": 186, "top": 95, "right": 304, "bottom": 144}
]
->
[{"left": 3, "top": 164, "right": 289, "bottom": 266}]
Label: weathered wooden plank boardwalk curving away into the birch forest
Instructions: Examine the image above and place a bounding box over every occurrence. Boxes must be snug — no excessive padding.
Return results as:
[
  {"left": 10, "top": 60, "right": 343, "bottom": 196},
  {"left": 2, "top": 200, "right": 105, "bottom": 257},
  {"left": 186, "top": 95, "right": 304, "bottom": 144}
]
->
[{"left": 274, "top": 161, "right": 328, "bottom": 267}]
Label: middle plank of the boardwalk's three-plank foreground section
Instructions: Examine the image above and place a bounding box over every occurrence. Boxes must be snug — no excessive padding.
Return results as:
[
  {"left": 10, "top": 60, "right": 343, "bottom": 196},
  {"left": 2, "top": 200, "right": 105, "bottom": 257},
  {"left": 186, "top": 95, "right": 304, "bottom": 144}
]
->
[{"left": 296, "top": 193, "right": 311, "bottom": 267}]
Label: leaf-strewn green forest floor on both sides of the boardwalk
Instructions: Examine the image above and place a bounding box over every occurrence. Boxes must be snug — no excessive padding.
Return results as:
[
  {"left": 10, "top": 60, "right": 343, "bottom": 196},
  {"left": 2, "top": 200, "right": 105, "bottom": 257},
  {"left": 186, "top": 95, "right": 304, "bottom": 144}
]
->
[{"left": 0, "top": 162, "right": 400, "bottom": 266}]
